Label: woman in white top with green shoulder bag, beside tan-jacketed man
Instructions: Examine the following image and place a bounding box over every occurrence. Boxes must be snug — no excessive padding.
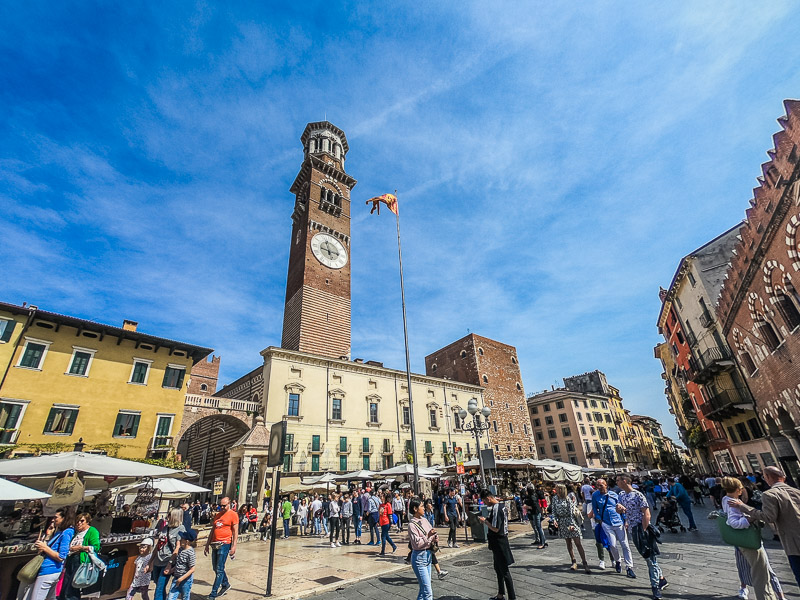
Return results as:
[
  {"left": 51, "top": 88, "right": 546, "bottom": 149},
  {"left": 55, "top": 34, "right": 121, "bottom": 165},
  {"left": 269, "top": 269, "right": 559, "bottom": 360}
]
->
[{"left": 722, "top": 477, "right": 783, "bottom": 600}]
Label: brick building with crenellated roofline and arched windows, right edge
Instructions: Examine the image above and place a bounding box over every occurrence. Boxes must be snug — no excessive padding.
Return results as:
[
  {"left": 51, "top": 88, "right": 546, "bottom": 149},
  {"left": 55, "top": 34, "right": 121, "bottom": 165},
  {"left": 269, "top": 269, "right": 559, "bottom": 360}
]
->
[{"left": 717, "top": 100, "right": 800, "bottom": 481}]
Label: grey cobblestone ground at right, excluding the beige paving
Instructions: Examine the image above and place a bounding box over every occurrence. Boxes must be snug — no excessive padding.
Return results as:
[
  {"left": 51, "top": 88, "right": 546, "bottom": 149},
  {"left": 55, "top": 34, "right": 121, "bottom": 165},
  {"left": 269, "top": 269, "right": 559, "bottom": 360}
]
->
[{"left": 315, "top": 507, "right": 800, "bottom": 600}]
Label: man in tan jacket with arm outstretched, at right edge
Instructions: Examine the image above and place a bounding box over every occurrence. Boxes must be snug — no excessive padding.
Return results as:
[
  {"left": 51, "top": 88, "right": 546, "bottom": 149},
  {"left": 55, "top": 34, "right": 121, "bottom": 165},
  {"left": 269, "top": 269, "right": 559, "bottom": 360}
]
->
[{"left": 728, "top": 467, "right": 800, "bottom": 586}]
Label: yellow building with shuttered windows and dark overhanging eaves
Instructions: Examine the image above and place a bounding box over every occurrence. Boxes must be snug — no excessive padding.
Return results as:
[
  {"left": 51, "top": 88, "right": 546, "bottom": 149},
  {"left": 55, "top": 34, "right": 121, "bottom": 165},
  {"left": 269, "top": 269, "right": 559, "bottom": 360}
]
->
[{"left": 0, "top": 303, "right": 211, "bottom": 458}]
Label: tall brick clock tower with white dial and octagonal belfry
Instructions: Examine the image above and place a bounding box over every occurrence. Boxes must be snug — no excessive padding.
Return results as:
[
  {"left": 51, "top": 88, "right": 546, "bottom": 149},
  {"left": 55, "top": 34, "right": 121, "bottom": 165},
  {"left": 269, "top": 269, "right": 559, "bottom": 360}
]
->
[{"left": 281, "top": 121, "right": 356, "bottom": 358}]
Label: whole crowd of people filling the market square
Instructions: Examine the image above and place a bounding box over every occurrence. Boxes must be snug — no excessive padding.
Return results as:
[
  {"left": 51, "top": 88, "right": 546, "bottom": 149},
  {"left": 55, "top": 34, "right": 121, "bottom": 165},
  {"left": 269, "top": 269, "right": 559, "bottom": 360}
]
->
[{"left": 18, "top": 467, "right": 800, "bottom": 600}]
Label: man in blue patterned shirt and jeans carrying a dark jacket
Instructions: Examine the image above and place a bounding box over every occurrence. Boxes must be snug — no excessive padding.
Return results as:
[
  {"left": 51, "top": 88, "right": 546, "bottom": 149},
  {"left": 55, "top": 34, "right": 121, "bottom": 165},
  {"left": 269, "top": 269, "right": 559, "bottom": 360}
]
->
[{"left": 617, "top": 475, "right": 669, "bottom": 600}]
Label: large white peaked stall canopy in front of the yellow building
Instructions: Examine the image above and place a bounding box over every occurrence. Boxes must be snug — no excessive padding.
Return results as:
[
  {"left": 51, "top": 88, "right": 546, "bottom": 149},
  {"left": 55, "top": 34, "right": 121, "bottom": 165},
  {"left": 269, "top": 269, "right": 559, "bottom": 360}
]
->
[{"left": 0, "top": 452, "right": 183, "bottom": 489}]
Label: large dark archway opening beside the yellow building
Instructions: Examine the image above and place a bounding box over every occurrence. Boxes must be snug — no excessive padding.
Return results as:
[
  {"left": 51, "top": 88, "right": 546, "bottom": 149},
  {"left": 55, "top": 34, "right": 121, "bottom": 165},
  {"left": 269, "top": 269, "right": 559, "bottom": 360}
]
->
[{"left": 178, "top": 414, "right": 249, "bottom": 489}]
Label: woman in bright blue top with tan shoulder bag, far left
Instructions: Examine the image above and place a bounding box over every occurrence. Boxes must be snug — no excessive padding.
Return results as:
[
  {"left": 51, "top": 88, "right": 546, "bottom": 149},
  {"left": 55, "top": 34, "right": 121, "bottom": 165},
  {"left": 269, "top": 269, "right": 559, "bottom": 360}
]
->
[{"left": 17, "top": 508, "right": 75, "bottom": 600}]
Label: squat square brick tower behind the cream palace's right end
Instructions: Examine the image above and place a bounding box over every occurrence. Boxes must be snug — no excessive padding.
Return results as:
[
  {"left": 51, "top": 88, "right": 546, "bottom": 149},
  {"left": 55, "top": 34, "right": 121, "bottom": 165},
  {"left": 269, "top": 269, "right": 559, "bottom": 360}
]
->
[{"left": 425, "top": 333, "right": 536, "bottom": 458}]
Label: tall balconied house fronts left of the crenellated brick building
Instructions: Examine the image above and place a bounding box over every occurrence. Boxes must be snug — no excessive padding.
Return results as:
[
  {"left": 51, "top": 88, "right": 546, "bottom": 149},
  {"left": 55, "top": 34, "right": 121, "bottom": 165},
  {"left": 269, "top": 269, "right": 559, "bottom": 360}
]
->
[{"left": 659, "top": 225, "right": 775, "bottom": 474}]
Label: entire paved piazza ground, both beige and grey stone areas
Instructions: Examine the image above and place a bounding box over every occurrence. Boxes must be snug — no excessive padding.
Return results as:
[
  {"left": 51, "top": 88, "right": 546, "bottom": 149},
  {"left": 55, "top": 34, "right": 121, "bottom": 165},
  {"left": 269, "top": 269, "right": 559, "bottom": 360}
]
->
[{"left": 192, "top": 507, "right": 800, "bottom": 600}]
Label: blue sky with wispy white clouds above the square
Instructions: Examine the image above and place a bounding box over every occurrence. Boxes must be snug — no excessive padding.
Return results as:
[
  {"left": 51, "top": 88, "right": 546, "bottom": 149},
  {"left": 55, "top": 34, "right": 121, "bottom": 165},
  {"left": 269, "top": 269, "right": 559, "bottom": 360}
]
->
[{"left": 0, "top": 2, "right": 800, "bottom": 435}]
